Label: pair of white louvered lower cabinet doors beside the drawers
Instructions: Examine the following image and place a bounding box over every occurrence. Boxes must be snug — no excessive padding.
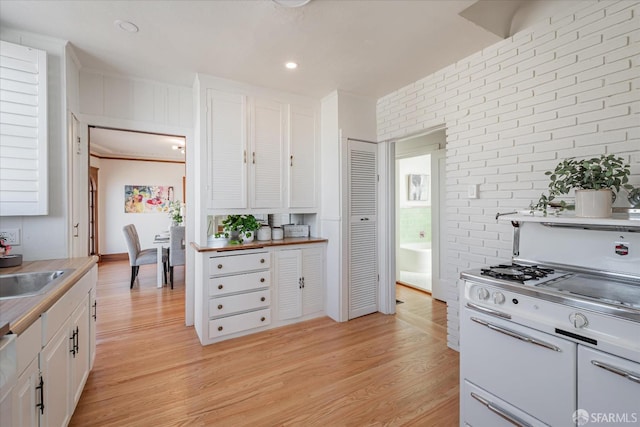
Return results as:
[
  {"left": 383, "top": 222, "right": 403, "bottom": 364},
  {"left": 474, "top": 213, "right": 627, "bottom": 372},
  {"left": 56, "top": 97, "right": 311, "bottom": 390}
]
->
[{"left": 275, "top": 247, "right": 324, "bottom": 320}]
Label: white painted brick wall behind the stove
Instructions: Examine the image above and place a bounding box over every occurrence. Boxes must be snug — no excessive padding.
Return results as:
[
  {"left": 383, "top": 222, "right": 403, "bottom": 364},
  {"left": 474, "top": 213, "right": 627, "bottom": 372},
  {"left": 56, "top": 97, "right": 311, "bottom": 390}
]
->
[{"left": 377, "top": 0, "right": 640, "bottom": 348}]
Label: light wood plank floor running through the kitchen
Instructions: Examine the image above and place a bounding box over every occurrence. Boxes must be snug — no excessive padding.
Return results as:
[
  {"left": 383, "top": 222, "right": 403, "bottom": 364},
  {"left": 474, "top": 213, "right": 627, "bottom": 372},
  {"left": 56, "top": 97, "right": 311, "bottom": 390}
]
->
[{"left": 70, "top": 261, "right": 458, "bottom": 427}]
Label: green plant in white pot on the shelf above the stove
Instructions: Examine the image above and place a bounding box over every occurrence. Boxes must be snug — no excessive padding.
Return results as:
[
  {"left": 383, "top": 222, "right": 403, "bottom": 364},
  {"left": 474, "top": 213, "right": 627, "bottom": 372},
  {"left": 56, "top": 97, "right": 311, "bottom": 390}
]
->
[{"left": 531, "top": 154, "right": 633, "bottom": 218}]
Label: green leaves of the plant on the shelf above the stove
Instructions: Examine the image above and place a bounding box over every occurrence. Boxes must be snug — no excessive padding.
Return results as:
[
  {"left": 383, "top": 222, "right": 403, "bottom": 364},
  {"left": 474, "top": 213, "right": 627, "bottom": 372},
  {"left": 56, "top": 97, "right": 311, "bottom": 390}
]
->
[{"left": 530, "top": 154, "right": 633, "bottom": 216}]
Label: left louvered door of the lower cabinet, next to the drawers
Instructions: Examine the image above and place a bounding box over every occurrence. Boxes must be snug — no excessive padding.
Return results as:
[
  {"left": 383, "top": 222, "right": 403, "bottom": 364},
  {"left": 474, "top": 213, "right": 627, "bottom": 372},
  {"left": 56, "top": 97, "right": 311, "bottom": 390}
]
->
[{"left": 276, "top": 249, "right": 302, "bottom": 320}]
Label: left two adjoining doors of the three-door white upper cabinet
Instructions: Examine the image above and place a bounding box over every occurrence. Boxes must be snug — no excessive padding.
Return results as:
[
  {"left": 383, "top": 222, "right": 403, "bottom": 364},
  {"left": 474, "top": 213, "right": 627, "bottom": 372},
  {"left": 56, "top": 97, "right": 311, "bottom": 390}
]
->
[{"left": 207, "top": 90, "right": 286, "bottom": 210}]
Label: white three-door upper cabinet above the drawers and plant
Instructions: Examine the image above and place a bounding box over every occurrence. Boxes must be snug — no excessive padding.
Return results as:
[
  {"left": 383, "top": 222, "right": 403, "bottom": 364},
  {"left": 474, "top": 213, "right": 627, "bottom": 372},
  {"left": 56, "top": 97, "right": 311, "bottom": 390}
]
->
[{"left": 202, "top": 85, "right": 318, "bottom": 214}]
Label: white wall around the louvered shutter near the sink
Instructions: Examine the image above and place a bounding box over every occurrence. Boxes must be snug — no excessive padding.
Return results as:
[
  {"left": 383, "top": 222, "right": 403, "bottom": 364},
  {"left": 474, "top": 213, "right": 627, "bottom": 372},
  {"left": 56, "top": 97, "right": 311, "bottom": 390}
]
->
[{"left": 0, "top": 29, "right": 69, "bottom": 261}]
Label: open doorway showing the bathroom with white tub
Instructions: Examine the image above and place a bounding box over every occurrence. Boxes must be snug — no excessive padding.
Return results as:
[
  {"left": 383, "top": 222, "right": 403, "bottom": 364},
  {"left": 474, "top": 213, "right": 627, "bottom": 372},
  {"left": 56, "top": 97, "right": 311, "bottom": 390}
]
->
[{"left": 395, "top": 129, "right": 446, "bottom": 301}]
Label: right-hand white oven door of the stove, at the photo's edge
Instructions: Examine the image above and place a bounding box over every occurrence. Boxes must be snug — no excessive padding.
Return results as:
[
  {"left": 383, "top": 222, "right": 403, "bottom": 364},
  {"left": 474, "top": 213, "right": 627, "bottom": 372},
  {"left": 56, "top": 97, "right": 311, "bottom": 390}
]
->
[{"left": 578, "top": 345, "right": 640, "bottom": 425}]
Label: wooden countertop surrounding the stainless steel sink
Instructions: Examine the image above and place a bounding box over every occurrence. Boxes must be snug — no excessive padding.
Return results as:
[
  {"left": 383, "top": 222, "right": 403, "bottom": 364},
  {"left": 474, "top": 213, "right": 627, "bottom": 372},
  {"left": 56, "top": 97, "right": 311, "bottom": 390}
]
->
[{"left": 0, "top": 256, "right": 98, "bottom": 334}]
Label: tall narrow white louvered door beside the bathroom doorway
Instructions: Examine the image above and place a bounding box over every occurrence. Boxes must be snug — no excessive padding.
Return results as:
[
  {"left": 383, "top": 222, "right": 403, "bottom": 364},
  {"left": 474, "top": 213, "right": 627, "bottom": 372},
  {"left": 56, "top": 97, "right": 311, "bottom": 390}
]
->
[{"left": 347, "top": 141, "right": 378, "bottom": 319}]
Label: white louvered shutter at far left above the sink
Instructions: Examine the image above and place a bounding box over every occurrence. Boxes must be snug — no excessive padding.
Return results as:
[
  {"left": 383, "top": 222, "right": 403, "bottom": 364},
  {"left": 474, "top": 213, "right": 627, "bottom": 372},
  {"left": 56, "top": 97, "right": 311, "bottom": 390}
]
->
[{"left": 0, "top": 41, "right": 48, "bottom": 216}]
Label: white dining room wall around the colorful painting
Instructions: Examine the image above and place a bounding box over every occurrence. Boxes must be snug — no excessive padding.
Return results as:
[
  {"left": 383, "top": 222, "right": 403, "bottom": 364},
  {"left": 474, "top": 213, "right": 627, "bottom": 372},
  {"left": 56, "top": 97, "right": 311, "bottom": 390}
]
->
[{"left": 98, "top": 159, "right": 185, "bottom": 254}]
